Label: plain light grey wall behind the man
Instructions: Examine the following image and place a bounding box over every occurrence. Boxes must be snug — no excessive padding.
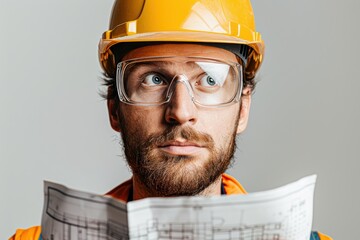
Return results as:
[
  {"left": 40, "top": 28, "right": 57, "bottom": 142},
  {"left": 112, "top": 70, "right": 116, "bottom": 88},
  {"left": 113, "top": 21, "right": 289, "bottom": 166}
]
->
[{"left": 0, "top": 0, "right": 360, "bottom": 239}]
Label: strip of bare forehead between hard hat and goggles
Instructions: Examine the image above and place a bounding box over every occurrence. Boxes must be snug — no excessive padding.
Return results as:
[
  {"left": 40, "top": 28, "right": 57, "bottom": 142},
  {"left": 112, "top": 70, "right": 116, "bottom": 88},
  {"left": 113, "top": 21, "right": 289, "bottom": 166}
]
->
[{"left": 123, "top": 43, "right": 237, "bottom": 62}]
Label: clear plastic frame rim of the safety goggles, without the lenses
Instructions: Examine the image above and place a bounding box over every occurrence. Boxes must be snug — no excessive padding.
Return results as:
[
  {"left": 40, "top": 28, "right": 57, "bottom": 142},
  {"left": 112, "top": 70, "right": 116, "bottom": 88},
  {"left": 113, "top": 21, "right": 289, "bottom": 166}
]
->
[{"left": 116, "top": 56, "right": 244, "bottom": 108}]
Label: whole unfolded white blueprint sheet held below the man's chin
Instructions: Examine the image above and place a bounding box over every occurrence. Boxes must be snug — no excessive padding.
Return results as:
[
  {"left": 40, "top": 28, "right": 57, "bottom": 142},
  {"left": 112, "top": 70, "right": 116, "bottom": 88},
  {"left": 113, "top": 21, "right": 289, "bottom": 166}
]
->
[{"left": 42, "top": 175, "right": 316, "bottom": 240}]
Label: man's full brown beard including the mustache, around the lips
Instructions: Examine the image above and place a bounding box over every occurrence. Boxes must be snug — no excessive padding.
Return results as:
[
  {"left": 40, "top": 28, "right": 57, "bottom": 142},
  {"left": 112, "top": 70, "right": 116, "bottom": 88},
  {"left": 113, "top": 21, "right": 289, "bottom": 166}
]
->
[{"left": 121, "top": 119, "right": 236, "bottom": 197}]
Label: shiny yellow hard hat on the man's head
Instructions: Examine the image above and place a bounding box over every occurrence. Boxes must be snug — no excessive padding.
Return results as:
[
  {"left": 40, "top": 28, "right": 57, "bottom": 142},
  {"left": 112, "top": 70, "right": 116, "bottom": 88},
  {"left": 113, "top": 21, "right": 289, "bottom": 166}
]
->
[{"left": 99, "top": 0, "right": 265, "bottom": 78}]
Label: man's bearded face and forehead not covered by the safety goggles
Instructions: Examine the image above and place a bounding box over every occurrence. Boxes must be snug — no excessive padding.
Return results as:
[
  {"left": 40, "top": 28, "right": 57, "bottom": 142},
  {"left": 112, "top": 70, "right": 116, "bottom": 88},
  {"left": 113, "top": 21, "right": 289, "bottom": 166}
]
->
[{"left": 108, "top": 44, "right": 250, "bottom": 196}]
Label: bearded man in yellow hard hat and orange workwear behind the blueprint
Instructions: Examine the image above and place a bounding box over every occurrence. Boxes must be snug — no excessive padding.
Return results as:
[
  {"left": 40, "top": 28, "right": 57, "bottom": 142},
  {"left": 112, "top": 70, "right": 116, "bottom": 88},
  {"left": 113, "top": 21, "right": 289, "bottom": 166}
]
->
[{"left": 11, "top": 0, "right": 330, "bottom": 240}]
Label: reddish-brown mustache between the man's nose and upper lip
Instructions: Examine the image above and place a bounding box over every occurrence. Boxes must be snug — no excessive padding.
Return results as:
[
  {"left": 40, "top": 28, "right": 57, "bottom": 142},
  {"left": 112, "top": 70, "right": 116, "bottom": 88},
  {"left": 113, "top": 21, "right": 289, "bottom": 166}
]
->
[{"left": 147, "top": 126, "right": 214, "bottom": 147}]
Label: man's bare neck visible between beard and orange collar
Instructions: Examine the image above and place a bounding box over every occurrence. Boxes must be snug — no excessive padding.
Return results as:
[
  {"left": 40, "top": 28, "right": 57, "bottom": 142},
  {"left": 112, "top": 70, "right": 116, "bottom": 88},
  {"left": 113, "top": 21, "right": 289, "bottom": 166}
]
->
[{"left": 132, "top": 176, "right": 222, "bottom": 200}]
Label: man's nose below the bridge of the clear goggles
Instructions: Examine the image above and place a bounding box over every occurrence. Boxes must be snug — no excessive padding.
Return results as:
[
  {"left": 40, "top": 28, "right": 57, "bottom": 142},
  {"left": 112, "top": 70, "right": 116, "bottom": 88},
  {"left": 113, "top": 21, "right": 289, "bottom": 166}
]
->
[{"left": 165, "top": 81, "right": 198, "bottom": 125}]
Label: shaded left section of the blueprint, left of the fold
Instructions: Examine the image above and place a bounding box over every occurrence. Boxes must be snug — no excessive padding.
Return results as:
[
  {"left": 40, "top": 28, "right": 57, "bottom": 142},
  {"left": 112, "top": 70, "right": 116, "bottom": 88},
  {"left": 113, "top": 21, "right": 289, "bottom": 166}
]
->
[{"left": 41, "top": 182, "right": 129, "bottom": 240}]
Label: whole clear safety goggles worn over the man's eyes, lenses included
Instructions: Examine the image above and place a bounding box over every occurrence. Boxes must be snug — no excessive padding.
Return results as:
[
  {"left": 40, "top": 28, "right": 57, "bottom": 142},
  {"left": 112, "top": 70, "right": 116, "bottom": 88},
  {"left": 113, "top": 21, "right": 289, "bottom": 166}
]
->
[{"left": 116, "top": 57, "right": 242, "bottom": 106}]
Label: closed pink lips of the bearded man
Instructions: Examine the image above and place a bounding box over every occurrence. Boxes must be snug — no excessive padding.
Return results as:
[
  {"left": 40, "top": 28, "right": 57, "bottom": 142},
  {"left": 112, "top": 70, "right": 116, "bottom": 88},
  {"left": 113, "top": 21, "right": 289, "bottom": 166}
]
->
[{"left": 159, "top": 140, "right": 205, "bottom": 156}]
